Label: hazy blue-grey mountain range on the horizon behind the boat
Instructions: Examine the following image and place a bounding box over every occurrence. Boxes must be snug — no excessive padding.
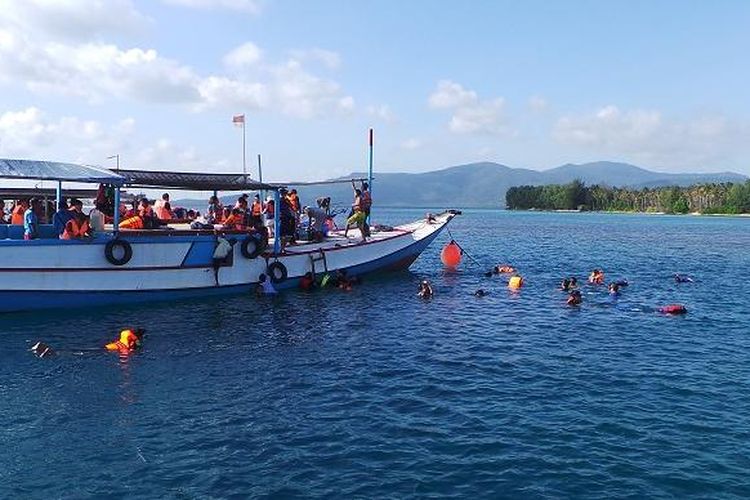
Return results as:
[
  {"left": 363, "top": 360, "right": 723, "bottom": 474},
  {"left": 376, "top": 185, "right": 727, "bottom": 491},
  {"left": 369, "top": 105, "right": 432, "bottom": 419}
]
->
[{"left": 176, "top": 161, "right": 747, "bottom": 208}]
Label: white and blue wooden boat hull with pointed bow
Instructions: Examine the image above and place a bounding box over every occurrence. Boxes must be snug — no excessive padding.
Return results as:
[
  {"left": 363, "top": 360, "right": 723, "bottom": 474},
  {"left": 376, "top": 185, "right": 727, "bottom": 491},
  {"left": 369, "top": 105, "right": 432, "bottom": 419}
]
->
[{"left": 0, "top": 213, "right": 454, "bottom": 312}]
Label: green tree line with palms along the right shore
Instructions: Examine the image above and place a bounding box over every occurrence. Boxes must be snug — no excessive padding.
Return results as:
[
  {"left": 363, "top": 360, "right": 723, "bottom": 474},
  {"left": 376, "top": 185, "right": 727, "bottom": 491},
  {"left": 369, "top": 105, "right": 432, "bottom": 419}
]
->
[{"left": 505, "top": 180, "right": 750, "bottom": 214}]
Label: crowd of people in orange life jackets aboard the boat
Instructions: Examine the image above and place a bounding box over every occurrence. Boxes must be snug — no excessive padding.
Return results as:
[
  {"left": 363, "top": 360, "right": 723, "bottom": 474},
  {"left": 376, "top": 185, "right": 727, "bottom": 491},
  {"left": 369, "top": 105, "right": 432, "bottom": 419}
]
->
[{"left": 0, "top": 182, "right": 372, "bottom": 248}]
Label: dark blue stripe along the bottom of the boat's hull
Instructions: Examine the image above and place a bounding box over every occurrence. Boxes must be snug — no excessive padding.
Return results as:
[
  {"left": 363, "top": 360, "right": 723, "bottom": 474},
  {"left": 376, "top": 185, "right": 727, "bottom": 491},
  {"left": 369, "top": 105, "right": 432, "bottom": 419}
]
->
[{"left": 0, "top": 226, "right": 445, "bottom": 312}]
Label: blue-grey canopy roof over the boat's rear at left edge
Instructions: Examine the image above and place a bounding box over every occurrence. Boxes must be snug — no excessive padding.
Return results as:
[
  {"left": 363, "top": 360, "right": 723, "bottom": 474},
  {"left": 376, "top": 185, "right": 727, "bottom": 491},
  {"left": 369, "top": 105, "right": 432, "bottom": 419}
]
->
[{"left": 0, "top": 158, "right": 125, "bottom": 186}]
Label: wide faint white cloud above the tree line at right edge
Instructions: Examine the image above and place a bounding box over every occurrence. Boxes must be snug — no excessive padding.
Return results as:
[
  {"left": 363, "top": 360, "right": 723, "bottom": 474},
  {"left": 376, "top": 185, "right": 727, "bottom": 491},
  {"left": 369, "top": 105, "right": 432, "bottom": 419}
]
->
[{"left": 553, "top": 105, "right": 747, "bottom": 166}]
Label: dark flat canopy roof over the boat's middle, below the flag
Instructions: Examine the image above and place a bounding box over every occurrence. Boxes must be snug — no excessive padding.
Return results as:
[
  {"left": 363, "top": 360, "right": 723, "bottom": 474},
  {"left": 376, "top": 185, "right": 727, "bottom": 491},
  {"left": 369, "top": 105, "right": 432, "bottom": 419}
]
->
[{"left": 118, "top": 169, "right": 276, "bottom": 191}]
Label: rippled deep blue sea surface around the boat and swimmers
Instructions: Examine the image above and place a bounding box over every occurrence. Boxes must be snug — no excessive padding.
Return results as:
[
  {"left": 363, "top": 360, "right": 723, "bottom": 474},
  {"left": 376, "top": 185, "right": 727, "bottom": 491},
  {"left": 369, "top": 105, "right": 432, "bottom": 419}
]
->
[{"left": 0, "top": 207, "right": 750, "bottom": 499}]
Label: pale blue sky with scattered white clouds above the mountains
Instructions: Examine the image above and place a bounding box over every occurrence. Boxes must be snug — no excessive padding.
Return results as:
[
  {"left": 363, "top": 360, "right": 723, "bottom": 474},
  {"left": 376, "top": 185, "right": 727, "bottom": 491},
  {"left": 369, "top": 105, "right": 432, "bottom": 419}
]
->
[{"left": 0, "top": 0, "right": 750, "bottom": 181}]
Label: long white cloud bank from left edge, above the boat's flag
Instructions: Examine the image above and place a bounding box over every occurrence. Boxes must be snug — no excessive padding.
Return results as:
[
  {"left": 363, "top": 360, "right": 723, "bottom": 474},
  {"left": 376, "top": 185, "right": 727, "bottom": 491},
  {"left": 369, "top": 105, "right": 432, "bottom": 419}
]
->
[{"left": 0, "top": 14, "right": 354, "bottom": 118}]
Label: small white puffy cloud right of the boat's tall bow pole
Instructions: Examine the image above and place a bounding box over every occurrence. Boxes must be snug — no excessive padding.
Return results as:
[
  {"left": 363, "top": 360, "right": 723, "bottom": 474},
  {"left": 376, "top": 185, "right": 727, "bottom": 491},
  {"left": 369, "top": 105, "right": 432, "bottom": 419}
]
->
[{"left": 428, "top": 80, "right": 512, "bottom": 135}]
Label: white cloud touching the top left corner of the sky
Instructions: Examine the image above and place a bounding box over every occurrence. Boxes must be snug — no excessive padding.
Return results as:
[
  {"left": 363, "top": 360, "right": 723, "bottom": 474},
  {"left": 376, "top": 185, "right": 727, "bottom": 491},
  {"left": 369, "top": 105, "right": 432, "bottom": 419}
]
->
[{"left": 0, "top": 0, "right": 152, "bottom": 40}]
